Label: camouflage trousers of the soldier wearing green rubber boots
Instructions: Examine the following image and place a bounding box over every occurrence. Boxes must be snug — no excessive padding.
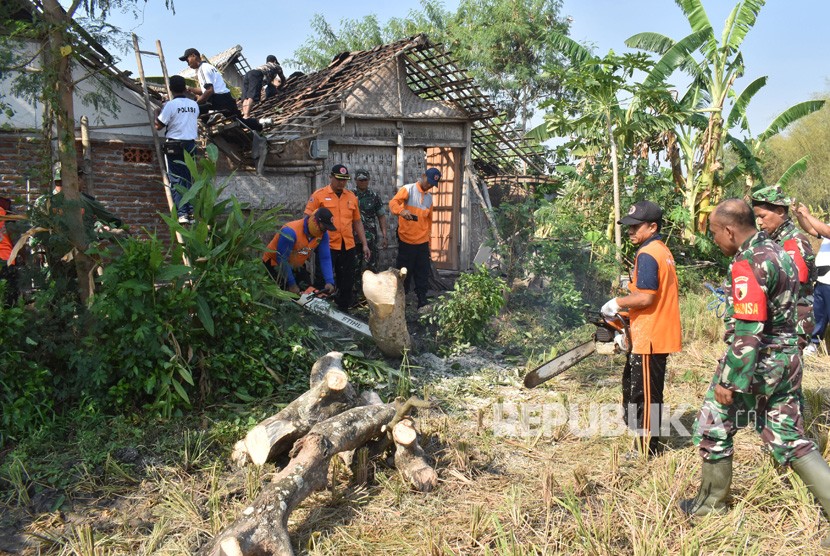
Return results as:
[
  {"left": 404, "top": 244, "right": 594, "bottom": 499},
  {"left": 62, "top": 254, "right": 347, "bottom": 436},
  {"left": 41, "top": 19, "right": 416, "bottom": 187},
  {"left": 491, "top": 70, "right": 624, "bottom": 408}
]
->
[{"left": 692, "top": 346, "right": 816, "bottom": 465}]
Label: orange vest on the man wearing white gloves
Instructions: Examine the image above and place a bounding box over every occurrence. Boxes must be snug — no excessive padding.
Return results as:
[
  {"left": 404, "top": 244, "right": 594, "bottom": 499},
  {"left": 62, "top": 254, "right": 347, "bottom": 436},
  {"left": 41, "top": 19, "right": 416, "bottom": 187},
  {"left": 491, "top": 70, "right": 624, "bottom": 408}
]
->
[{"left": 628, "top": 239, "right": 681, "bottom": 354}]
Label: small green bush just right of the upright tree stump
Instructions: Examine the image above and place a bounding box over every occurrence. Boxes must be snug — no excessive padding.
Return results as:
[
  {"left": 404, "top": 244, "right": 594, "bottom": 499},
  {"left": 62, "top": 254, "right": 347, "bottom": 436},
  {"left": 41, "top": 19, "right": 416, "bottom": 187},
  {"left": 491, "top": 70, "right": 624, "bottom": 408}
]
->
[{"left": 424, "top": 265, "right": 507, "bottom": 347}]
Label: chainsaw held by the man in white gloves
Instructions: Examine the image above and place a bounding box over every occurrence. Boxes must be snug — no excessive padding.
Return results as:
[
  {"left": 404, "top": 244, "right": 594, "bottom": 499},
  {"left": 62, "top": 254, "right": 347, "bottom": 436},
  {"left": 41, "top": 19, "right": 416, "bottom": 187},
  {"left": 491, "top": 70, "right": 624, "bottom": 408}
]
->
[{"left": 525, "top": 312, "right": 631, "bottom": 388}]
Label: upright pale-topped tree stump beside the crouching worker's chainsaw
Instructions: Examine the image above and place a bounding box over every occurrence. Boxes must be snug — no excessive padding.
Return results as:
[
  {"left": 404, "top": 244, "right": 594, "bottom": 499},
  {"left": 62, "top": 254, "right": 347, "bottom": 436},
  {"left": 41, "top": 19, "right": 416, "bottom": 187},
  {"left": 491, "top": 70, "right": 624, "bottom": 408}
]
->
[{"left": 363, "top": 268, "right": 411, "bottom": 357}]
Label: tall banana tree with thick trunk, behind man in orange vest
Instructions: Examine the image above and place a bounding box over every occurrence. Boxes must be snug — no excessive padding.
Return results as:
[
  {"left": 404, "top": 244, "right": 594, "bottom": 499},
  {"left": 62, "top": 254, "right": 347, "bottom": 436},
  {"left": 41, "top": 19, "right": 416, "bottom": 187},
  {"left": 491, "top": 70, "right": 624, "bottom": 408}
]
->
[{"left": 626, "top": 0, "right": 765, "bottom": 232}]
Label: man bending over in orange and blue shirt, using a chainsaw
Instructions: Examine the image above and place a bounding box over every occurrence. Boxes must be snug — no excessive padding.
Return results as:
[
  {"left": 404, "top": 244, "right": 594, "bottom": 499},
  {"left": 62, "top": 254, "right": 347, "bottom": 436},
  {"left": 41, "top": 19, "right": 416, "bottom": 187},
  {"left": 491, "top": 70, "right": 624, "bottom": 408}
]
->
[{"left": 262, "top": 207, "right": 337, "bottom": 293}]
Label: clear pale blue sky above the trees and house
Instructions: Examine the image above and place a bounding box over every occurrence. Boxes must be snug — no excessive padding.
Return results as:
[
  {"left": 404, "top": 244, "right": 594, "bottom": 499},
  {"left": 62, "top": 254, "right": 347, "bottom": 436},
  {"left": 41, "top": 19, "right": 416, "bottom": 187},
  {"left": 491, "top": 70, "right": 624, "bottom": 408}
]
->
[{"left": 105, "top": 0, "right": 830, "bottom": 134}]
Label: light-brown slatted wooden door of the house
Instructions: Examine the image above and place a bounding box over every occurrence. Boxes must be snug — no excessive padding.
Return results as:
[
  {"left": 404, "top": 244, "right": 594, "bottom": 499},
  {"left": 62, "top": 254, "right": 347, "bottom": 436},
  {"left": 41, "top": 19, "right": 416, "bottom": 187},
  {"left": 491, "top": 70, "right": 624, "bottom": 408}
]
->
[{"left": 426, "top": 147, "right": 461, "bottom": 270}]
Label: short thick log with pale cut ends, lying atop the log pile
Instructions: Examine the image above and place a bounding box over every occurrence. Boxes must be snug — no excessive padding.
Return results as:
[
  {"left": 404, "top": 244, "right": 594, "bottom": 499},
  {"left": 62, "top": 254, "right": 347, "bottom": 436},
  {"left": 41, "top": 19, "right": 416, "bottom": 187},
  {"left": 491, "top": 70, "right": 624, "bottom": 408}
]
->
[{"left": 240, "top": 368, "right": 361, "bottom": 465}]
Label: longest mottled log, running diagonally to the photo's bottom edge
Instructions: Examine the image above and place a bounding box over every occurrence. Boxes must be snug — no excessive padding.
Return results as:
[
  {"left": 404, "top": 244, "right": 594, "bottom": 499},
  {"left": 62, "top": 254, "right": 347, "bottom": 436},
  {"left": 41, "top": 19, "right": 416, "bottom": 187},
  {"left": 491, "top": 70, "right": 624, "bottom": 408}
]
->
[{"left": 202, "top": 404, "right": 396, "bottom": 556}]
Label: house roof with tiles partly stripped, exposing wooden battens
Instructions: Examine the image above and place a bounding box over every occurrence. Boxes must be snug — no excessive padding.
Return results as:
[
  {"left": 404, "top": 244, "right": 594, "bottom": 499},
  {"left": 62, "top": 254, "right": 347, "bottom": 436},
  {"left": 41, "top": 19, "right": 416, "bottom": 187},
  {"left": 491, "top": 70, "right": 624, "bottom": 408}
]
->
[{"left": 252, "top": 35, "right": 544, "bottom": 174}]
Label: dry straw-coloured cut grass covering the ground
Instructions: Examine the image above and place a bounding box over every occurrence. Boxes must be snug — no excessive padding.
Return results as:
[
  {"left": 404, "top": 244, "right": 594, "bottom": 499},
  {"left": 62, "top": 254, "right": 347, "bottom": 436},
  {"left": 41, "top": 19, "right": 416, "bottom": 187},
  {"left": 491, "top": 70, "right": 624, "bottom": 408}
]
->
[{"left": 1, "top": 294, "right": 830, "bottom": 556}]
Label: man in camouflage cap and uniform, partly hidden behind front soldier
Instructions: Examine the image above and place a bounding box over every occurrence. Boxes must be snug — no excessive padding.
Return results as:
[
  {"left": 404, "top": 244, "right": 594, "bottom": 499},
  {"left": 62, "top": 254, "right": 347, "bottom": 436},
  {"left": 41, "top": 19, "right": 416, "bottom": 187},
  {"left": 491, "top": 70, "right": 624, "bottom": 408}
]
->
[{"left": 752, "top": 185, "right": 816, "bottom": 350}]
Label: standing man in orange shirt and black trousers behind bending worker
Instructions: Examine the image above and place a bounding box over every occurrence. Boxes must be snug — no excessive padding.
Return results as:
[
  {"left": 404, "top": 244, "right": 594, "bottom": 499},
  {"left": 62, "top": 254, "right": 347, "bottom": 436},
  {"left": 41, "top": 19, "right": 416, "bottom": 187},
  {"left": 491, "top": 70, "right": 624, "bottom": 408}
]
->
[{"left": 305, "top": 164, "right": 371, "bottom": 312}]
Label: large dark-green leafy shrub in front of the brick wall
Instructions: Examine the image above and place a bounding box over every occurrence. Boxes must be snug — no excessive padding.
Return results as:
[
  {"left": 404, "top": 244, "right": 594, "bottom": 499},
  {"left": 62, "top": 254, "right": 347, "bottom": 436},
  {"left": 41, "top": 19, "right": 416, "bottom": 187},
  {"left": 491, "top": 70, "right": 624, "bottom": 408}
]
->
[{"left": 67, "top": 148, "right": 311, "bottom": 417}]
